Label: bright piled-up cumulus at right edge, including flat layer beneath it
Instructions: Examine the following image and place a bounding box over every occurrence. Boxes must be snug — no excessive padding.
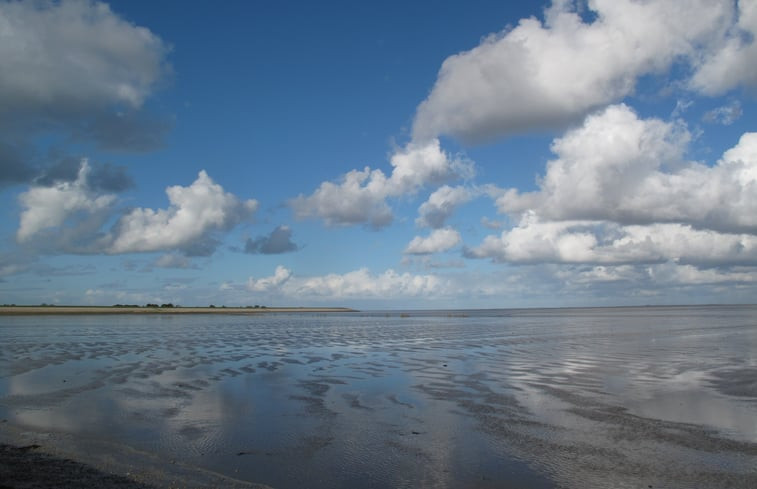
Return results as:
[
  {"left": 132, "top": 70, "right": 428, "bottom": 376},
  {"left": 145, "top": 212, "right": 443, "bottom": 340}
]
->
[{"left": 466, "top": 105, "right": 757, "bottom": 282}]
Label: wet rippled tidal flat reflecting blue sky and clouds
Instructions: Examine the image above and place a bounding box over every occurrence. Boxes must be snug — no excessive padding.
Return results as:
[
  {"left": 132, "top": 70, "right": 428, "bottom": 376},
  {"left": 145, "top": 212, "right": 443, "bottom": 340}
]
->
[{"left": 0, "top": 306, "right": 757, "bottom": 488}]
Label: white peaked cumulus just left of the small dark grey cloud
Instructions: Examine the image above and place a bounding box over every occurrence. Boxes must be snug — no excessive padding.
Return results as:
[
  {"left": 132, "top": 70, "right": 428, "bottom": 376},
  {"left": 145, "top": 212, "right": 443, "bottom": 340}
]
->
[{"left": 108, "top": 170, "right": 258, "bottom": 253}]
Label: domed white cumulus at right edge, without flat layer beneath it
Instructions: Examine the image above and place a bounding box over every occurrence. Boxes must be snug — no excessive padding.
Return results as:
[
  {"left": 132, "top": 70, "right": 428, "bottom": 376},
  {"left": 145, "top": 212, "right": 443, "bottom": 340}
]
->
[{"left": 497, "top": 105, "right": 757, "bottom": 233}]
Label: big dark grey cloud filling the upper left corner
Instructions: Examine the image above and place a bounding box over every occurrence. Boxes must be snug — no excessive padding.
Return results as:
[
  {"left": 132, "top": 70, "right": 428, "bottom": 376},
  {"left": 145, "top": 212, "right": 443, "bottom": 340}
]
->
[{"left": 0, "top": 0, "right": 170, "bottom": 185}]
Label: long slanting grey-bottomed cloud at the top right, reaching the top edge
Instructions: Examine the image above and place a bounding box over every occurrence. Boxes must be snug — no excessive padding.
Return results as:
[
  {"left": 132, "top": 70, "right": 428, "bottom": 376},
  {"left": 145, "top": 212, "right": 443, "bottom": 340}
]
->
[{"left": 413, "top": 0, "right": 736, "bottom": 142}]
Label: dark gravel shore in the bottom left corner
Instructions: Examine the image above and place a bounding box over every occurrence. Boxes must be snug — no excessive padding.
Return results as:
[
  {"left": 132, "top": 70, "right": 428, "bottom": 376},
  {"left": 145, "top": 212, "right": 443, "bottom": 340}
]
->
[{"left": 0, "top": 445, "right": 153, "bottom": 489}]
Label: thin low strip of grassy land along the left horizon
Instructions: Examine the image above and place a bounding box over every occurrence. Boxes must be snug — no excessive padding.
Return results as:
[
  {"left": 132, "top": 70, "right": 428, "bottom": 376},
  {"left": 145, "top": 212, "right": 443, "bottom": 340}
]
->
[{"left": 0, "top": 306, "right": 357, "bottom": 316}]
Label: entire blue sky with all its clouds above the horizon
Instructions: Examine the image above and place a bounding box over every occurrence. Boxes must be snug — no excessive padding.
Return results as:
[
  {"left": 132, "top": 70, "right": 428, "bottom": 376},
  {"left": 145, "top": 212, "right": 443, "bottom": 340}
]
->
[{"left": 0, "top": 0, "right": 757, "bottom": 309}]
